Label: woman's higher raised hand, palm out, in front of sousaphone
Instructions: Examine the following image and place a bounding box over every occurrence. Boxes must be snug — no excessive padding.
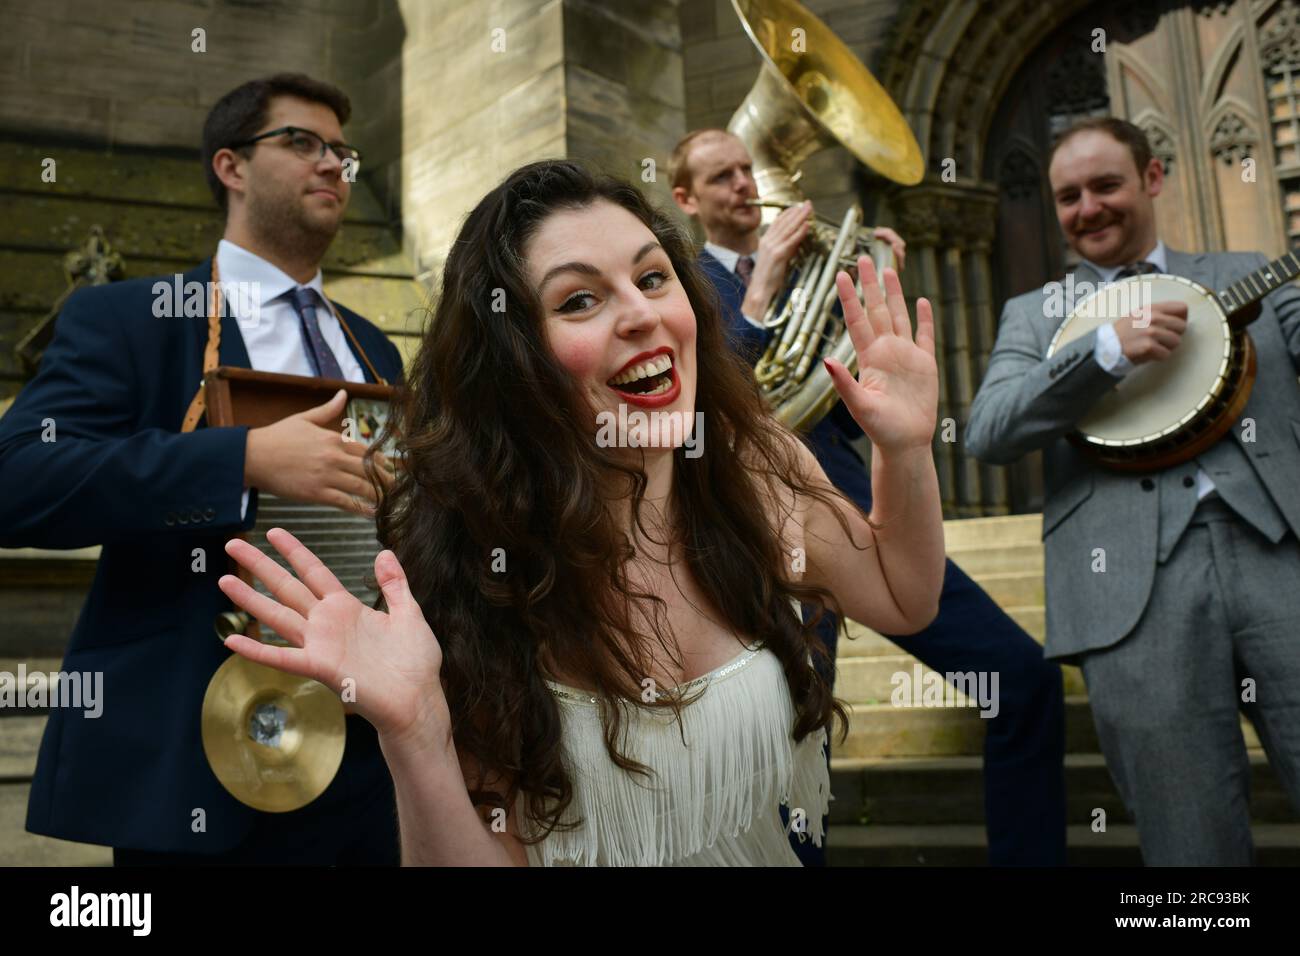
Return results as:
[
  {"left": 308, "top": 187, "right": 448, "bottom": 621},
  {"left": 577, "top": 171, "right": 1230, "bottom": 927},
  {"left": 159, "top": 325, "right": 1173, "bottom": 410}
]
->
[{"left": 826, "top": 256, "right": 939, "bottom": 454}]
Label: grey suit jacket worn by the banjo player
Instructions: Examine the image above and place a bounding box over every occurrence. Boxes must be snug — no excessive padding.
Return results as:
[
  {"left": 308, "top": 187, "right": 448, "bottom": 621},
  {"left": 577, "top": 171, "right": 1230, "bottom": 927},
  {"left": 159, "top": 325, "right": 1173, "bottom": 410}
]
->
[{"left": 966, "top": 250, "right": 1300, "bottom": 659}]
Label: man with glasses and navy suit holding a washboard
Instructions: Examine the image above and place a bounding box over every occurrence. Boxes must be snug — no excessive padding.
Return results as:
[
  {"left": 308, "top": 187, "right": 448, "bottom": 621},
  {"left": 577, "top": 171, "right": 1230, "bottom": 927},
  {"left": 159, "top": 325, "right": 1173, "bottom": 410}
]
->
[{"left": 0, "top": 74, "right": 402, "bottom": 865}]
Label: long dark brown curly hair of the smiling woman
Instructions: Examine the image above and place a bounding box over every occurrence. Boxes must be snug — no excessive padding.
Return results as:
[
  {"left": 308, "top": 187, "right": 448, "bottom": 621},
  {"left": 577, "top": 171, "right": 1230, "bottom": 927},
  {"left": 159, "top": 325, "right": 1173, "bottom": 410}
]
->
[{"left": 371, "top": 160, "right": 863, "bottom": 839}]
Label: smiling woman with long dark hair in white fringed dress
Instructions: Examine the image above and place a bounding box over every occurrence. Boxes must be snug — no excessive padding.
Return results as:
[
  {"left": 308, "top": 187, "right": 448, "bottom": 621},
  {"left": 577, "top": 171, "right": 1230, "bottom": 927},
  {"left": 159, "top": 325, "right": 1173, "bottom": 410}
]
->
[{"left": 222, "top": 161, "right": 944, "bottom": 865}]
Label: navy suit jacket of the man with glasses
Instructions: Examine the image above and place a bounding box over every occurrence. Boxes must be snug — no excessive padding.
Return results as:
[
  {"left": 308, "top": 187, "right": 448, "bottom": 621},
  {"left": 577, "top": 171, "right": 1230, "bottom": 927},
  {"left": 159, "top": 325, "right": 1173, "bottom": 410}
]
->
[{"left": 0, "top": 260, "right": 402, "bottom": 853}]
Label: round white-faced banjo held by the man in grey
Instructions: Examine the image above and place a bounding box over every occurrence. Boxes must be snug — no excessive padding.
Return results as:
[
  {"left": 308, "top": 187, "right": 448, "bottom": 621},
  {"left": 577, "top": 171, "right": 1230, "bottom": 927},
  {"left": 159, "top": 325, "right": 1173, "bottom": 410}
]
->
[{"left": 1047, "top": 252, "right": 1300, "bottom": 471}]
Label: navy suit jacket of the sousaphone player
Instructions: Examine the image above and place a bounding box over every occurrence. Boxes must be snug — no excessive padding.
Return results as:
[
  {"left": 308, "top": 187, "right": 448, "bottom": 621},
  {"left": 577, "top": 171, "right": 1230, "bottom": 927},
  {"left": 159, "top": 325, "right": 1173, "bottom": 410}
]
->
[{"left": 699, "top": 248, "right": 871, "bottom": 502}]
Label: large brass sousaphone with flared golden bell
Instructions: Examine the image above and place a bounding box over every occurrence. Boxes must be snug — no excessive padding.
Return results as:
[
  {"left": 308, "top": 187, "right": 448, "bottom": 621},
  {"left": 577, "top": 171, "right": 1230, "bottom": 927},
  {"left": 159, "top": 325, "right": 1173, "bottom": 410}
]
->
[{"left": 727, "top": 0, "right": 926, "bottom": 431}]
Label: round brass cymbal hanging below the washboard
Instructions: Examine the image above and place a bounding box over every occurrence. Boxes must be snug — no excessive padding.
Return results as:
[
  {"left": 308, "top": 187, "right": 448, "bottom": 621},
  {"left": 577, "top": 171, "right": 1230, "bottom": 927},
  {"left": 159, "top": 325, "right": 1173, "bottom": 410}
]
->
[{"left": 202, "top": 654, "right": 347, "bottom": 813}]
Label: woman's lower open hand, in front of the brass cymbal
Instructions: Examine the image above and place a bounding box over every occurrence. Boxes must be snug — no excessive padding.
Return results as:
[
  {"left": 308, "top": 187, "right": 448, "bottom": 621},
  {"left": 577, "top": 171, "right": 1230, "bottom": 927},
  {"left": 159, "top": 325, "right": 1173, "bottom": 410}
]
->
[{"left": 218, "top": 528, "right": 450, "bottom": 737}]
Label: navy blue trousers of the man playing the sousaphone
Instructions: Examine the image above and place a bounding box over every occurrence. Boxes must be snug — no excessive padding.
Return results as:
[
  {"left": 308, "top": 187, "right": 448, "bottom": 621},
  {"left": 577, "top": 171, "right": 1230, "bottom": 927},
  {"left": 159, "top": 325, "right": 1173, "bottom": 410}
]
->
[{"left": 783, "top": 416, "right": 1065, "bottom": 866}]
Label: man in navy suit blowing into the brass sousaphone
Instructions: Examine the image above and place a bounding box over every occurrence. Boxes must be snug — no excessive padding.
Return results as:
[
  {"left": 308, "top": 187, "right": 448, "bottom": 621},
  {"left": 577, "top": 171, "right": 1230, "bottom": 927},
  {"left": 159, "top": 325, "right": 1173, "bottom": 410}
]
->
[{"left": 670, "top": 129, "right": 1065, "bottom": 866}]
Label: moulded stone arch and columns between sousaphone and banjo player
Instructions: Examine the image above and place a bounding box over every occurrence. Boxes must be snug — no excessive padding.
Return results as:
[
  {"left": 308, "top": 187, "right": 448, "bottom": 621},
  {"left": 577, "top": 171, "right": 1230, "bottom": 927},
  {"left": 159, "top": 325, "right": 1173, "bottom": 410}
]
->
[{"left": 880, "top": 0, "right": 1088, "bottom": 518}]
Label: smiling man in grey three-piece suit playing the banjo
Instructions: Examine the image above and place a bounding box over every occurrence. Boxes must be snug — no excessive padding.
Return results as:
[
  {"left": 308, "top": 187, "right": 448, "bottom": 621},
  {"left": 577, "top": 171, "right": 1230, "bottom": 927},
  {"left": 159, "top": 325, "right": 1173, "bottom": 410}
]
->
[{"left": 966, "top": 118, "right": 1300, "bottom": 865}]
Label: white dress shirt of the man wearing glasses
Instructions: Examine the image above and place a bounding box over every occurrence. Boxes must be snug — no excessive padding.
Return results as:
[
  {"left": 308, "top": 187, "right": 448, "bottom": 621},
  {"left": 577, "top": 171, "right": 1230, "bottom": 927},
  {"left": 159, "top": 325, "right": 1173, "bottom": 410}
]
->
[{"left": 217, "top": 239, "right": 365, "bottom": 518}]
